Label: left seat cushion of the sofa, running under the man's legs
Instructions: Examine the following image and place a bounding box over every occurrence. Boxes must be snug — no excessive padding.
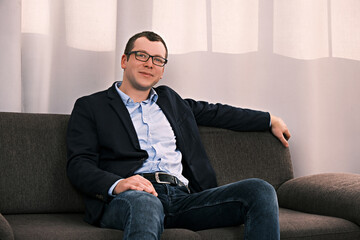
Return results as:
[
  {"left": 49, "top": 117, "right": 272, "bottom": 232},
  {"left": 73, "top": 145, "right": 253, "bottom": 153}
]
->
[{"left": 6, "top": 214, "right": 201, "bottom": 240}]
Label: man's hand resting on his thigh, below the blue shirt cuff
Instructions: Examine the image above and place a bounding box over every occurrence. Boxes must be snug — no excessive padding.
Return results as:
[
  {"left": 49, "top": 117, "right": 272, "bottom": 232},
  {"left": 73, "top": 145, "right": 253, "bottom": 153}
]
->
[{"left": 113, "top": 175, "right": 158, "bottom": 197}]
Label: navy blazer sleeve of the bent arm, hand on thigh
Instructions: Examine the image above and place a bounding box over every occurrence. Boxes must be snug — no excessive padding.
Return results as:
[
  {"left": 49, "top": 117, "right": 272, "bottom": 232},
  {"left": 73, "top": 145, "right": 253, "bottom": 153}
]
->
[{"left": 67, "top": 97, "right": 120, "bottom": 202}]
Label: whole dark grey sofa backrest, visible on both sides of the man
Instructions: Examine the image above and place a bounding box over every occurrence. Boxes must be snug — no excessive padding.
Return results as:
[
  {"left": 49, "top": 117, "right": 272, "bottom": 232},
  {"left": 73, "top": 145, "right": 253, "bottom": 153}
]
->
[{"left": 0, "top": 113, "right": 293, "bottom": 214}]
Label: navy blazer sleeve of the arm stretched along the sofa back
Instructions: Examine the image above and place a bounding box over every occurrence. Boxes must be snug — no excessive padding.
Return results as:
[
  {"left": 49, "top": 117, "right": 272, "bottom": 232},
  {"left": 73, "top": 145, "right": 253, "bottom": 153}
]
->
[{"left": 185, "top": 99, "right": 270, "bottom": 131}]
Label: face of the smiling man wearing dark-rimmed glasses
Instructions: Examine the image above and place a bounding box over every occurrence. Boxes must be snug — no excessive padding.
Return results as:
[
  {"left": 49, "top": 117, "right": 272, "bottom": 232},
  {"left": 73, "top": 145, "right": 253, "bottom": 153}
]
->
[{"left": 121, "top": 37, "right": 166, "bottom": 91}]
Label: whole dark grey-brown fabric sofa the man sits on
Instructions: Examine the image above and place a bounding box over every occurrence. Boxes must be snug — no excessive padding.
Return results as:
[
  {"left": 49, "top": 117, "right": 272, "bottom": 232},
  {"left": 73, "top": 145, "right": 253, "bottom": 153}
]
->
[{"left": 0, "top": 113, "right": 360, "bottom": 240}]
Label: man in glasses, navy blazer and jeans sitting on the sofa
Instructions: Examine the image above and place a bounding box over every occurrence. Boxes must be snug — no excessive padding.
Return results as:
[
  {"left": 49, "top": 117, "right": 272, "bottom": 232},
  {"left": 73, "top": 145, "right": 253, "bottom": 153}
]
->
[{"left": 67, "top": 32, "right": 290, "bottom": 240}]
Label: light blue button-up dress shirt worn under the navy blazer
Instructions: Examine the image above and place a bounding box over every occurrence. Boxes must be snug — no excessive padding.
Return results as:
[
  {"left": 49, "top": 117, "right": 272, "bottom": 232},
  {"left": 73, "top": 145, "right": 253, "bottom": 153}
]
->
[{"left": 109, "top": 82, "right": 189, "bottom": 195}]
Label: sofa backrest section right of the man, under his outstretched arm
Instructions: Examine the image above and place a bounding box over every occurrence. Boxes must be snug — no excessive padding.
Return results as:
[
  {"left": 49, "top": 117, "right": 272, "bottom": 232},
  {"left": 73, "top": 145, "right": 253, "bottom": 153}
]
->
[{"left": 199, "top": 127, "right": 294, "bottom": 189}]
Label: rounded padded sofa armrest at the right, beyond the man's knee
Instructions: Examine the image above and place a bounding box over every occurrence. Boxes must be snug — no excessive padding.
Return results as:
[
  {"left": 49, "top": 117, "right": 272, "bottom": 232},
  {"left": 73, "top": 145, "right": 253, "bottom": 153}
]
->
[{"left": 277, "top": 173, "right": 360, "bottom": 225}]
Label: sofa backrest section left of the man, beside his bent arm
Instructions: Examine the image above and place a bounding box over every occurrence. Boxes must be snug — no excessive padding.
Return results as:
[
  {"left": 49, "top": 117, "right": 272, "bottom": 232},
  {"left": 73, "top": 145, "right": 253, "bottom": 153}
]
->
[{"left": 0, "top": 113, "right": 84, "bottom": 214}]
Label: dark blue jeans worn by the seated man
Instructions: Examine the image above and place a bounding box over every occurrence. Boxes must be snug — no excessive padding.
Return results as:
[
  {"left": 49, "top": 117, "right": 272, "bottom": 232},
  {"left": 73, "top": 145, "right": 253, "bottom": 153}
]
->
[{"left": 101, "top": 179, "right": 280, "bottom": 240}]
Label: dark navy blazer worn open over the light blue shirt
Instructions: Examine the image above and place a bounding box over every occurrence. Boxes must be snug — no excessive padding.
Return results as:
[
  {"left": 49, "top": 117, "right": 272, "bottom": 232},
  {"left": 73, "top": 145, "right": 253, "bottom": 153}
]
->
[{"left": 67, "top": 84, "right": 270, "bottom": 225}]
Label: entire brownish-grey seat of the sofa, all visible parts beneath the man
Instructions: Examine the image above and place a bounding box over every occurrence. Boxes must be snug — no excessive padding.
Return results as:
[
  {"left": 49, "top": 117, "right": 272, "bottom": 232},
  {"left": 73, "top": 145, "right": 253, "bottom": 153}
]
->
[{"left": 5, "top": 208, "right": 360, "bottom": 240}]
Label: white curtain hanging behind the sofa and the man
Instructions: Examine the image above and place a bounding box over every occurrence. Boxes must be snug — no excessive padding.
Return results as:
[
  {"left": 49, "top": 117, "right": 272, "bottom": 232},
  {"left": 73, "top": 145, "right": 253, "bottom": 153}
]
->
[{"left": 0, "top": 0, "right": 360, "bottom": 176}]
